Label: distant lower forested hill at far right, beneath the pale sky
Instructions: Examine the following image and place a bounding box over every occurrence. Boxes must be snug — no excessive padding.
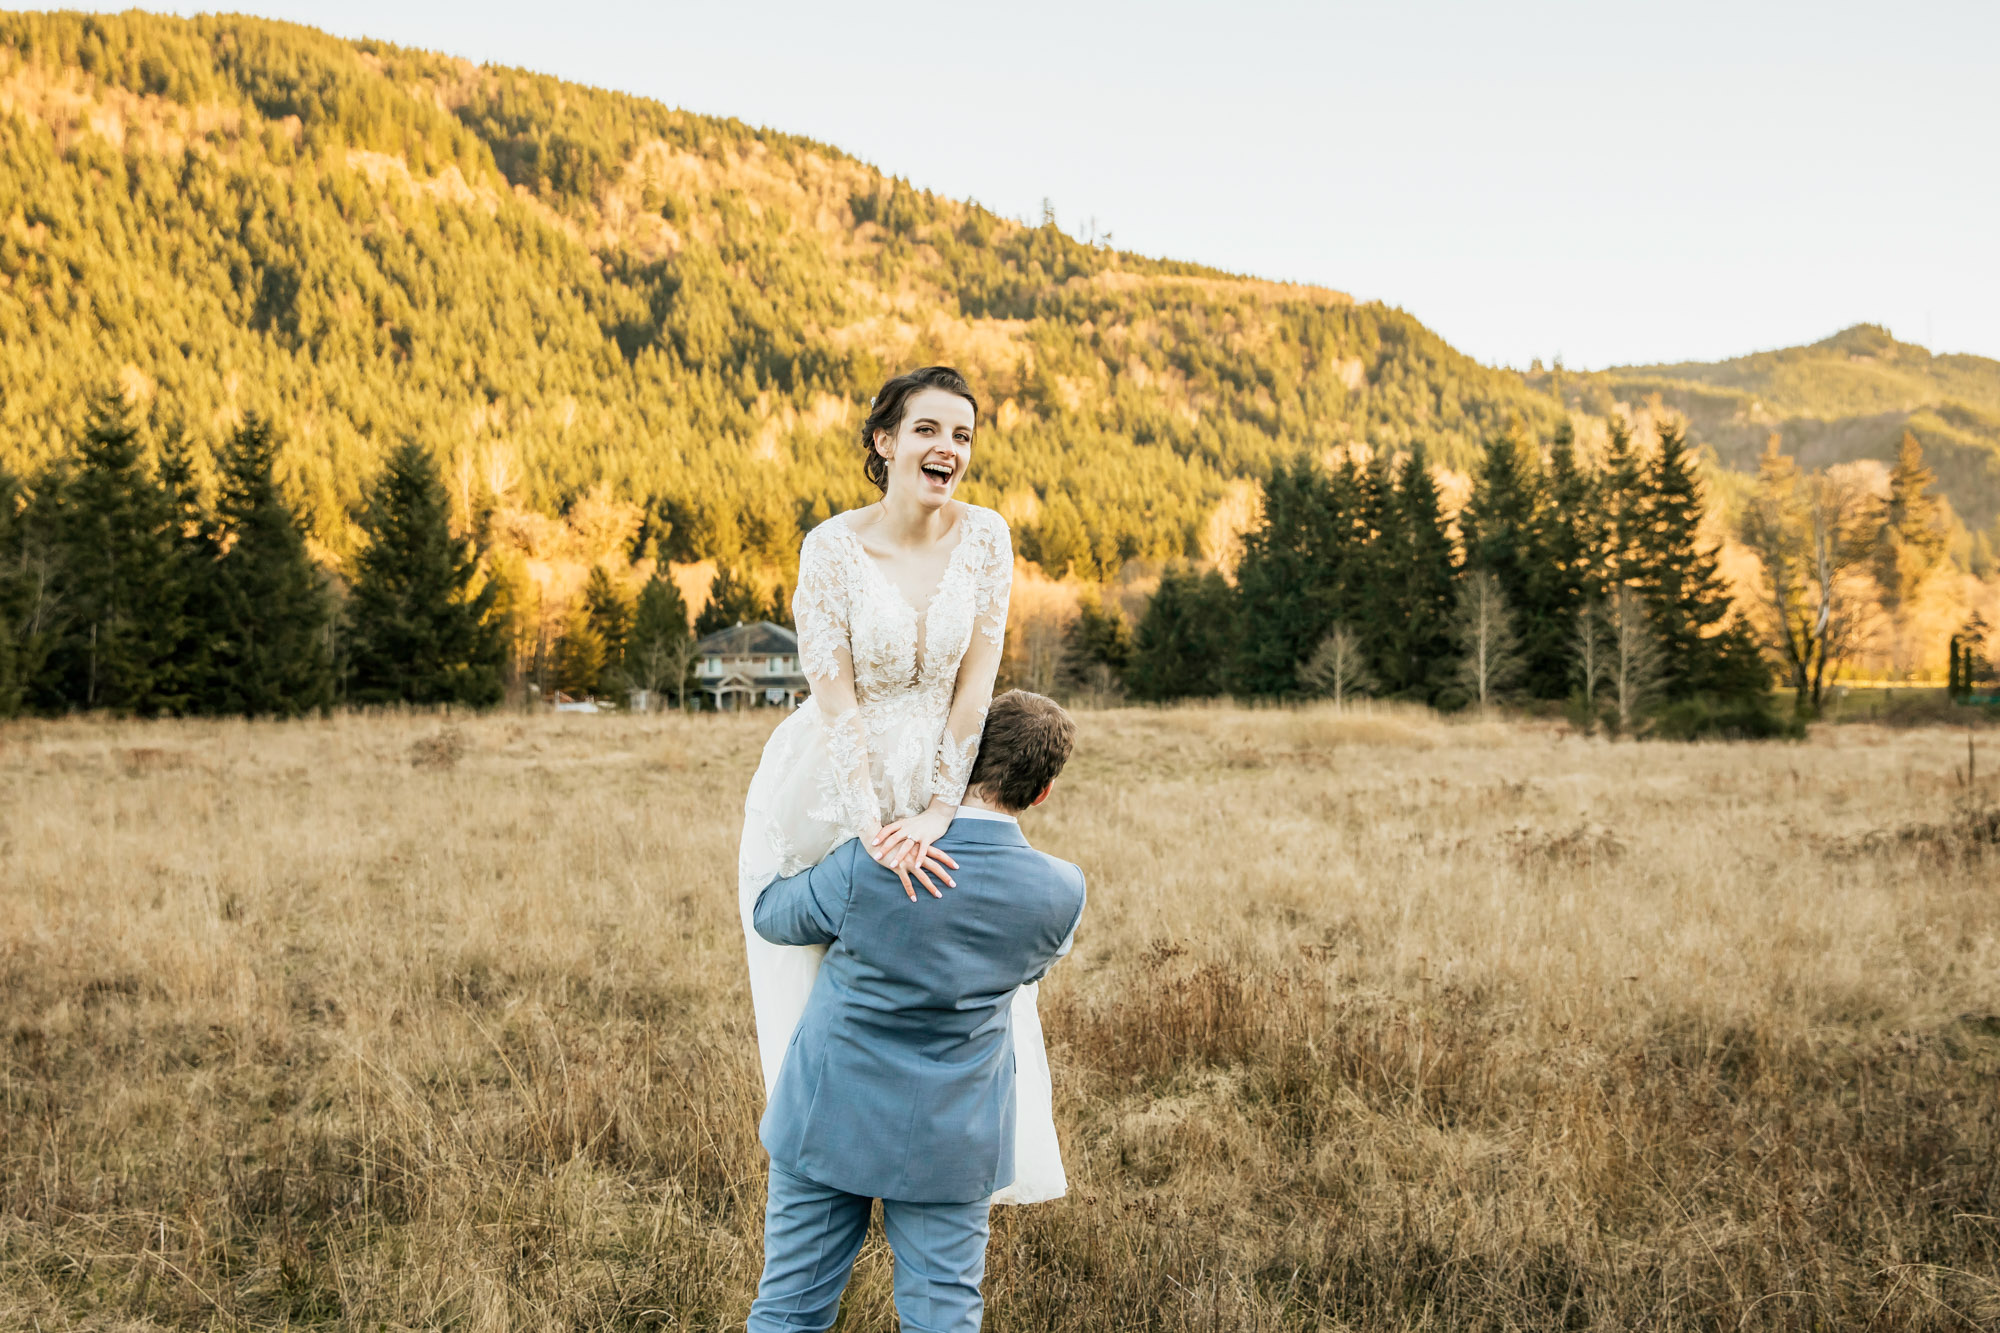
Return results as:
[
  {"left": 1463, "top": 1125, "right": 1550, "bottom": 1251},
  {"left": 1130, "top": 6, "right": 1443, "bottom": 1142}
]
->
[{"left": 1528, "top": 324, "right": 2000, "bottom": 536}]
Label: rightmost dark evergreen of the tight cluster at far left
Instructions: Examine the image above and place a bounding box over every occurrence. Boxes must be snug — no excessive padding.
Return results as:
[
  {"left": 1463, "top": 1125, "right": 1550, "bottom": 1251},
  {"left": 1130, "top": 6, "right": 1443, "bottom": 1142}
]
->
[{"left": 202, "top": 416, "right": 334, "bottom": 717}]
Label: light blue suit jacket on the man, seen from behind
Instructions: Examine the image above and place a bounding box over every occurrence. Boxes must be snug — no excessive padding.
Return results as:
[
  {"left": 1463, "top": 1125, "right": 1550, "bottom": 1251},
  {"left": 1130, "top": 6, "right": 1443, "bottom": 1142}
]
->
[{"left": 754, "top": 819, "right": 1084, "bottom": 1203}]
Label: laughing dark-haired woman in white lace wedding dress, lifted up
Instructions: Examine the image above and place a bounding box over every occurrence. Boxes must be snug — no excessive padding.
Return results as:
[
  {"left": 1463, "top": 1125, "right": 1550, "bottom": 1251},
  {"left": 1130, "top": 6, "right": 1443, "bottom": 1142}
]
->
[{"left": 736, "top": 366, "right": 1068, "bottom": 1203}]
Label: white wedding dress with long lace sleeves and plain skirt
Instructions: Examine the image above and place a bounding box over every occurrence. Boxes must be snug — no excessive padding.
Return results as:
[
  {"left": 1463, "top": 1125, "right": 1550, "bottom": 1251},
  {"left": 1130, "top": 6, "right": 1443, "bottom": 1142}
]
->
[{"left": 736, "top": 504, "right": 1068, "bottom": 1203}]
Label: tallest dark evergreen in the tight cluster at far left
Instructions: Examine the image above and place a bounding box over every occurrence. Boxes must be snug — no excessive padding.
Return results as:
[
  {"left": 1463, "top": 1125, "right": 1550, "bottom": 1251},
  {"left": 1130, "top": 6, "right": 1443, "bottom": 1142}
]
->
[{"left": 34, "top": 392, "right": 188, "bottom": 715}]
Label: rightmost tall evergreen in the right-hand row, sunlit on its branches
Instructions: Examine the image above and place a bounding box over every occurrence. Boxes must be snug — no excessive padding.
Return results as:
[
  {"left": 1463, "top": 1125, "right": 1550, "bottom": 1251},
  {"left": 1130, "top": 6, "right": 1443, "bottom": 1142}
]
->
[{"left": 1630, "top": 422, "right": 1770, "bottom": 699}]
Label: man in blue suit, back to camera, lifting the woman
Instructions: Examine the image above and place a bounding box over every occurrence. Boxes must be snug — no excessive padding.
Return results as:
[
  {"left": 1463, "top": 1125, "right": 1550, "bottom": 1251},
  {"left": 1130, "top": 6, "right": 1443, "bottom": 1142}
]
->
[{"left": 750, "top": 691, "right": 1084, "bottom": 1333}]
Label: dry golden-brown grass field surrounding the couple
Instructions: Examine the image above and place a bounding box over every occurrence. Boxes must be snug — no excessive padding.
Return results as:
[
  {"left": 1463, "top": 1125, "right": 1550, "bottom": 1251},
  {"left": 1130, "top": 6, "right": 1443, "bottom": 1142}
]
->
[{"left": 0, "top": 709, "right": 2000, "bottom": 1331}]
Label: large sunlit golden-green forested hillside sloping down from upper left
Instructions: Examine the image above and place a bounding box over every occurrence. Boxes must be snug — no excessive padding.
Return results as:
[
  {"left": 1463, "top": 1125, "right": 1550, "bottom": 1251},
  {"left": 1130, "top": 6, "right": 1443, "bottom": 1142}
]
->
[{"left": 0, "top": 14, "right": 1560, "bottom": 580}]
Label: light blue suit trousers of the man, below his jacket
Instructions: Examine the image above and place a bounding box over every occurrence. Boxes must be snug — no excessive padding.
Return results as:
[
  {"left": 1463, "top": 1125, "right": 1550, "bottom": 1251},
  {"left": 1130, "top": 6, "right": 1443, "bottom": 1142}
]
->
[{"left": 748, "top": 1163, "right": 992, "bottom": 1333}]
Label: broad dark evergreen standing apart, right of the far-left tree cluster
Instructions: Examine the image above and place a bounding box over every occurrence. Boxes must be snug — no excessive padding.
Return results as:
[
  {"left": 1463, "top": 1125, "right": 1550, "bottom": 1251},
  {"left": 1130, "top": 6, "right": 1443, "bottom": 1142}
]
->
[{"left": 348, "top": 442, "right": 506, "bottom": 707}]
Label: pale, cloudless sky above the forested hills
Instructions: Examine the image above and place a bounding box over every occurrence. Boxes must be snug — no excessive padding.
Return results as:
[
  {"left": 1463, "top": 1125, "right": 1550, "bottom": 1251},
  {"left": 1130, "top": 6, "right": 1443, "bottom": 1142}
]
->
[{"left": 145, "top": 0, "right": 2000, "bottom": 368}]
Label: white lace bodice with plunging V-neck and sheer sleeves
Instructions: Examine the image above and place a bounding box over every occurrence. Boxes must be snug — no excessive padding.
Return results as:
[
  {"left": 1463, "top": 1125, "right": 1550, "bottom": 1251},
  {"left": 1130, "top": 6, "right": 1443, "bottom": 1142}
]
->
[{"left": 792, "top": 504, "right": 1014, "bottom": 833}]
